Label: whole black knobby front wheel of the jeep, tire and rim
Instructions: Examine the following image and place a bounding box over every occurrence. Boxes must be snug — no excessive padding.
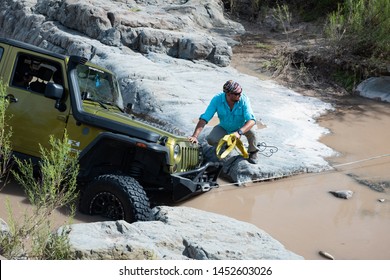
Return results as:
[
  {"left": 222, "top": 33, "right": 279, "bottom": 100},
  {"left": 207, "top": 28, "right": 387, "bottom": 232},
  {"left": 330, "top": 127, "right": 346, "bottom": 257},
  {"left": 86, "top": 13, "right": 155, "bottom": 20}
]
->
[{"left": 79, "top": 174, "right": 152, "bottom": 223}]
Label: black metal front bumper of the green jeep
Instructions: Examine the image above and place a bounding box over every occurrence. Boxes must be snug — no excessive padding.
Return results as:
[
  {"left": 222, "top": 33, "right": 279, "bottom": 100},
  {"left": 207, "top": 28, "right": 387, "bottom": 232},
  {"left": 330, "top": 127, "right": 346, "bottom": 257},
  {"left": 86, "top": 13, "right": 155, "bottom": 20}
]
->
[{"left": 172, "top": 162, "right": 222, "bottom": 201}]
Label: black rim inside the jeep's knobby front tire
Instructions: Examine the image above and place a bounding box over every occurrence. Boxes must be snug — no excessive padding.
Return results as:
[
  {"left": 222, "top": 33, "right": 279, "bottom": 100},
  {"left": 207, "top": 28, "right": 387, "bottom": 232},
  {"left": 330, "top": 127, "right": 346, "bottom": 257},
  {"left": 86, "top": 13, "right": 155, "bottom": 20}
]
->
[{"left": 89, "top": 192, "right": 125, "bottom": 220}]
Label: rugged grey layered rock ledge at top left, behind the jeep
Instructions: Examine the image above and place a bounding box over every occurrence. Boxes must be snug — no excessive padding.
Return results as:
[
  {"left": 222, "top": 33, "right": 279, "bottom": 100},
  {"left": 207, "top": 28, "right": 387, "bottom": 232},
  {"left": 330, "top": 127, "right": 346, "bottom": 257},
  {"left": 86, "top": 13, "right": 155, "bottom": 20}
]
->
[{"left": 0, "top": 0, "right": 244, "bottom": 66}]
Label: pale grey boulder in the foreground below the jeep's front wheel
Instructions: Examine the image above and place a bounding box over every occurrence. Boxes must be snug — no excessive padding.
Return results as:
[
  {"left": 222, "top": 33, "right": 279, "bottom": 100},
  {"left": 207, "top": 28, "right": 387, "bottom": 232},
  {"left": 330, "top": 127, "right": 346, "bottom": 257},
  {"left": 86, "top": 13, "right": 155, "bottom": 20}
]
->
[{"left": 58, "top": 206, "right": 302, "bottom": 260}]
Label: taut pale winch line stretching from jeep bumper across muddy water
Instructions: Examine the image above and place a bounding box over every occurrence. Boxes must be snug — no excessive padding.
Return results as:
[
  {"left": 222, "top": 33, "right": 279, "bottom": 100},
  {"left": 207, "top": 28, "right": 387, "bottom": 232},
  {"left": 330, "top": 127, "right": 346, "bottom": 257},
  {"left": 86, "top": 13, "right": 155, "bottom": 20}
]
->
[{"left": 215, "top": 151, "right": 390, "bottom": 187}]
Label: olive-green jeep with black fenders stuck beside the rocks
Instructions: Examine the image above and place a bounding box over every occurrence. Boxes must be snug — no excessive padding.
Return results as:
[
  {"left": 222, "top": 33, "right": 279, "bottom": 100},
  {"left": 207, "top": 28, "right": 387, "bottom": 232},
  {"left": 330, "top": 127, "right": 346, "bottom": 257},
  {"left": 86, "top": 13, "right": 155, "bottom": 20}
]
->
[{"left": 0, "top": 38, "right": 221, "bottom": 222}]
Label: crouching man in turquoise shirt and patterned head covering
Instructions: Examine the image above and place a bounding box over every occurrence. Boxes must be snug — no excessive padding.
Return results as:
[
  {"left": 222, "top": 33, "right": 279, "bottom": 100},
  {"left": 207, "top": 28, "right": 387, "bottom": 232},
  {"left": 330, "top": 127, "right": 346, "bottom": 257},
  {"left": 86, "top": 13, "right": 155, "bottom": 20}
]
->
[{"left": 188, "top": 80, "right": 258, "bottom": 164}]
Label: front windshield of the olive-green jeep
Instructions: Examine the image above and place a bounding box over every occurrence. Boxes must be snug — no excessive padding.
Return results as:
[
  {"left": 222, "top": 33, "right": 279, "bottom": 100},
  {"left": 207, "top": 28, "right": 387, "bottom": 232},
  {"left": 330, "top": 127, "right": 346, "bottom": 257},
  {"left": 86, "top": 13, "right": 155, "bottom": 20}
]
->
[{"left": 76, "top": 64, "right": 123, "bottom": 110}]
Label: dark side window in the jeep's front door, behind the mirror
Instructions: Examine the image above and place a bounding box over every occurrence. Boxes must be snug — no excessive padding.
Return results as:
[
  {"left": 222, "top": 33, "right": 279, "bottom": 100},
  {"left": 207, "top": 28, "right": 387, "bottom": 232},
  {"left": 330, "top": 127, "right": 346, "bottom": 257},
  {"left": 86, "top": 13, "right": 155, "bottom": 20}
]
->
[{"left": 12, "top": 54, "right": 62, "bottom": 94}]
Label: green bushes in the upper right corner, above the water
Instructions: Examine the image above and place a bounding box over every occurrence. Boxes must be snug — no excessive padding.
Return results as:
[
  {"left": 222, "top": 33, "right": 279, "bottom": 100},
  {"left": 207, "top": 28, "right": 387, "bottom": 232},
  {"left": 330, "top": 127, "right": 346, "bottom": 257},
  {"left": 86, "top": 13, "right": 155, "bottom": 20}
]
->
[{"left": 325, "top": 0, "right": 390, "bottom": 89}]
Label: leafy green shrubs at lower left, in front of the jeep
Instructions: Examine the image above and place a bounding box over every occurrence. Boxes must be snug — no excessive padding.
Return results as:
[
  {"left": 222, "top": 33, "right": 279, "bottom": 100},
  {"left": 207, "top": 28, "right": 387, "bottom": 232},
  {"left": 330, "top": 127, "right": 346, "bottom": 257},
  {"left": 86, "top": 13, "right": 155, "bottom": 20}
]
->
[{"left": 0, "top": 81, "right": 78, "bottom": 259}]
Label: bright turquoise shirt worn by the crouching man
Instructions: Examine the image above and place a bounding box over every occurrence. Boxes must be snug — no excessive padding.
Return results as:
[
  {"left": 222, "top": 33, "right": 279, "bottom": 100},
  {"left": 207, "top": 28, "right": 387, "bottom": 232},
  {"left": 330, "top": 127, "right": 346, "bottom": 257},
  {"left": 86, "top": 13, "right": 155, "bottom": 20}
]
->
[{"left": 200, "top": 92, "right": 256, "bottom": 134}]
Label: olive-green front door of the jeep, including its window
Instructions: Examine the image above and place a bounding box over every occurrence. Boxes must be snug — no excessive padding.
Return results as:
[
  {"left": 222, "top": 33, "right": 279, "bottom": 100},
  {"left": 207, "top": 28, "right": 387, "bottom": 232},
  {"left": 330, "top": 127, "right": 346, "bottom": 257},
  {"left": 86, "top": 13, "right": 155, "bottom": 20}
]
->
[{"left": 7, "top": 48, "right": 69, "bottom": 157}]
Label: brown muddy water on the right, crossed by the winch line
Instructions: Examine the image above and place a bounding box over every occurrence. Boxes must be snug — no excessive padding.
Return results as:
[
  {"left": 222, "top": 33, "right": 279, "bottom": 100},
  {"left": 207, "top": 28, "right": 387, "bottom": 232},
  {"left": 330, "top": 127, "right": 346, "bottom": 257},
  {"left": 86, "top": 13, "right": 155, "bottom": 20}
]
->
[{"left": 182, "top": 98, "right": 390, "bottom": 260}]
